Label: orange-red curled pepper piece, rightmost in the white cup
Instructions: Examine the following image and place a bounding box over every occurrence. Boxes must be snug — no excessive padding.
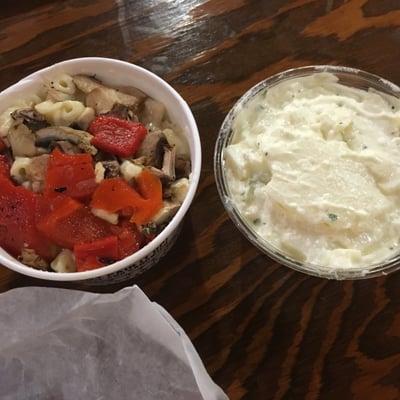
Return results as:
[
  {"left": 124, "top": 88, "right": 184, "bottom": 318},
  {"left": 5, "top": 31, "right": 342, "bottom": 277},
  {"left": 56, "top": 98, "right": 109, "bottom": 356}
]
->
[{"left": 91, "top": 170, "right": 162, "bottom": 225}]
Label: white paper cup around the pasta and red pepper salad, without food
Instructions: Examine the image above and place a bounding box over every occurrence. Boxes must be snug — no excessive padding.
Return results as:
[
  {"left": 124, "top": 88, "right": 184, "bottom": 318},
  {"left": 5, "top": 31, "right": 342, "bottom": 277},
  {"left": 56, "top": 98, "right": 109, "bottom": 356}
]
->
[{"left": 0, "top": 57, "right": 201, "bottom": 285}]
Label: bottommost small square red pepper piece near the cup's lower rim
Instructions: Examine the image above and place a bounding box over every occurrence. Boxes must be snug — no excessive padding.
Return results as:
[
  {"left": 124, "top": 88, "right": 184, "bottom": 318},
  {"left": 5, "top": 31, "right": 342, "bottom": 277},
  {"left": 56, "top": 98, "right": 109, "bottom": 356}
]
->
[{"left": 74, "top": 236, "right": 119, "bottom": 272}]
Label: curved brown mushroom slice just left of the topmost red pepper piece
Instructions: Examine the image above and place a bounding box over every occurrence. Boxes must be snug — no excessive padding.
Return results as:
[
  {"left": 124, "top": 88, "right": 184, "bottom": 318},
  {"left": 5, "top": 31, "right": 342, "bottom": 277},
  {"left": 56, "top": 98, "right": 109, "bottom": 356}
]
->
[{"left": 36, "top": 126, "right": 97, "bottom": 155}]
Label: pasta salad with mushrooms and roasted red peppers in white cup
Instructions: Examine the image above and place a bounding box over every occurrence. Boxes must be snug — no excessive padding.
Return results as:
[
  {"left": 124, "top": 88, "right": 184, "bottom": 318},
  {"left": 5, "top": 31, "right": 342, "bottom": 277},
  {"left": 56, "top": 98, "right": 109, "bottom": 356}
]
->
[{"left": 0, "top": 74, "right": 191, "bottom": 272}]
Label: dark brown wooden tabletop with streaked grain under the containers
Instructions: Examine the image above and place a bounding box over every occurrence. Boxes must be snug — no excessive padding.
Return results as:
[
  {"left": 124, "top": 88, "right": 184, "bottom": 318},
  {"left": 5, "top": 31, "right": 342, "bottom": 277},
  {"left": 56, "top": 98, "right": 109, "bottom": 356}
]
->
[{"left": 0, "top": 0, "right": 400, "bottom": 400}]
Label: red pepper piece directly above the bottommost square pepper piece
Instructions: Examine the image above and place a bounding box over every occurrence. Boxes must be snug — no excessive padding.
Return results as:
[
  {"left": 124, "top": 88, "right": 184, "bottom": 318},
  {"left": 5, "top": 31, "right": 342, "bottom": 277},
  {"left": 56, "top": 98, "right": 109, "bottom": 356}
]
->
[{"left": 37, "top": 197, "right": 111, "bottom": 249}]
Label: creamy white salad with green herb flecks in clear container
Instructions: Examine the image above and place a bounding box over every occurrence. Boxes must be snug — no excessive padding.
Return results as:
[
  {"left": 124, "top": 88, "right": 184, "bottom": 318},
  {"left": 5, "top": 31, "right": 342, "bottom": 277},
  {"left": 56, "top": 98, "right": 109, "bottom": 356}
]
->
[{"left": 224, "top": 73, "right": 400, "bottom": 268}]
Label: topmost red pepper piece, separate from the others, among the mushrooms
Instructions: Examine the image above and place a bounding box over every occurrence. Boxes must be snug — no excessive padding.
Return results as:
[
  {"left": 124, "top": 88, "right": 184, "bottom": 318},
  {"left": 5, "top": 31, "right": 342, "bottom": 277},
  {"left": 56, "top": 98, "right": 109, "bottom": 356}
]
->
[{"left": 88, "top": 115, "right": 147, "bottom": 157}]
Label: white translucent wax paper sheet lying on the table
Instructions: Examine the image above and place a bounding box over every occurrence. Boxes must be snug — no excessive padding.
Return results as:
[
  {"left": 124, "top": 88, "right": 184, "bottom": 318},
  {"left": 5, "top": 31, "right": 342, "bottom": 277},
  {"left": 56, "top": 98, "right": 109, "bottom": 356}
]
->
[{"left": 0, "top": 286, "right": 228, "bottom": 400}]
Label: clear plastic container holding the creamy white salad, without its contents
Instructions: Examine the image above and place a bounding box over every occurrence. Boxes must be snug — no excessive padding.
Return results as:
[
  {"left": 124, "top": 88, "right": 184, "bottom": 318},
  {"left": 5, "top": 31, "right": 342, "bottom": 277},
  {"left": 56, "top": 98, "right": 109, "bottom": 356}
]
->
[{"left": 214, "top": 65, "right": 400, "bottom": 280}]
